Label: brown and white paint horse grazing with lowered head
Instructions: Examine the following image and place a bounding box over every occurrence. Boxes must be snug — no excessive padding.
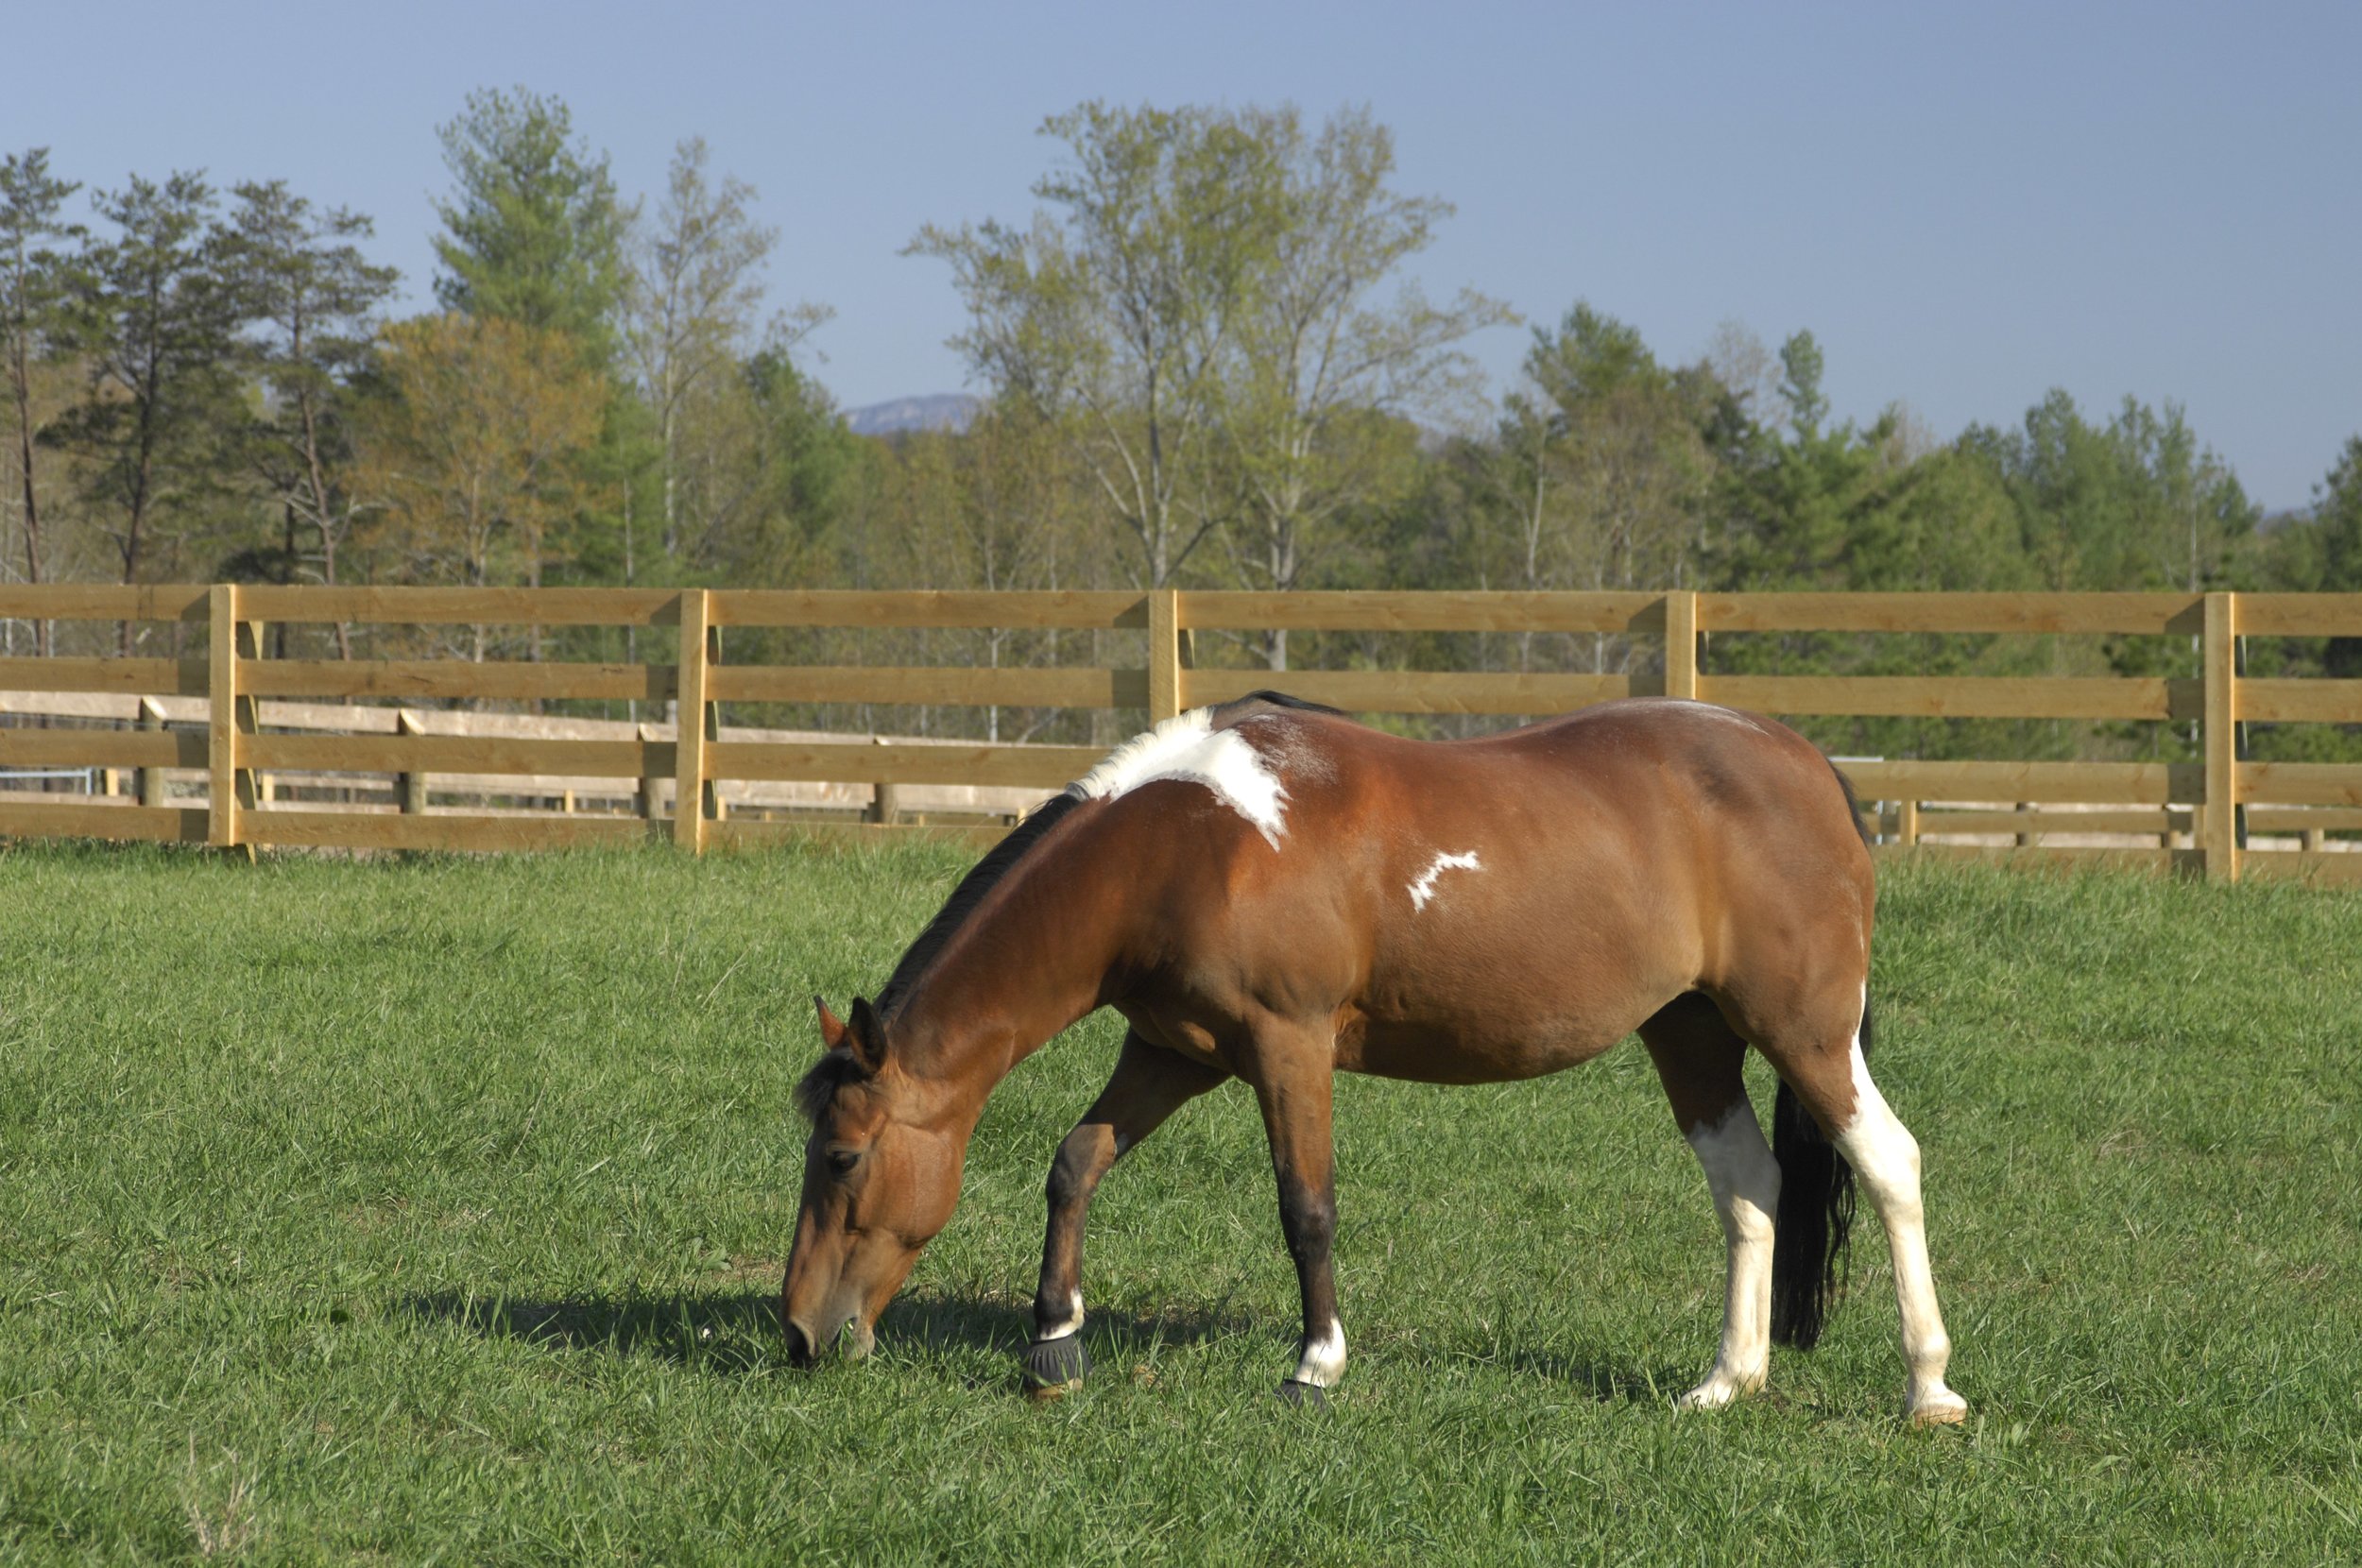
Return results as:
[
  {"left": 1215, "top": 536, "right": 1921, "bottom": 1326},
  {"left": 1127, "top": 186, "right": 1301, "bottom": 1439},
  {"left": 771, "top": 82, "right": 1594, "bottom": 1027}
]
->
[{"left": 782, "top": 694, "right": 1968, "bottom": 1422}]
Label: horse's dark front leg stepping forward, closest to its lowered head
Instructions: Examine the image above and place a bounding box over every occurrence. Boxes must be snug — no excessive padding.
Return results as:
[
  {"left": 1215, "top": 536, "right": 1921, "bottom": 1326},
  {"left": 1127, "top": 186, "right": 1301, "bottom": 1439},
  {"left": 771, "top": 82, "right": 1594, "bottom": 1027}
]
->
[{"left": 1025, "top": 1034, "right": 1228, "bottom": 1396}]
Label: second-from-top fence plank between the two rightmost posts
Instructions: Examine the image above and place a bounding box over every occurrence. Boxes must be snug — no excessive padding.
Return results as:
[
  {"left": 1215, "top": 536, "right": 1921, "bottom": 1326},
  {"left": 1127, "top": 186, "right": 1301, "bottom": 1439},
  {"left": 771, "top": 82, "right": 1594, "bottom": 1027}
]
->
[{"left": 1699, "top": 675, "right": 2173, "bottom": 718}]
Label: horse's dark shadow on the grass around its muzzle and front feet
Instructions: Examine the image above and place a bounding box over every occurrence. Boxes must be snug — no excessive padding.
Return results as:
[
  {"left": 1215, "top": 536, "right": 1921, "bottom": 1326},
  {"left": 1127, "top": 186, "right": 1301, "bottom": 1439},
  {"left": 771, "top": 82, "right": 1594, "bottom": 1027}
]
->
[{"left": 392, "top": 1289, "right": 1271, "bottom": 1387}]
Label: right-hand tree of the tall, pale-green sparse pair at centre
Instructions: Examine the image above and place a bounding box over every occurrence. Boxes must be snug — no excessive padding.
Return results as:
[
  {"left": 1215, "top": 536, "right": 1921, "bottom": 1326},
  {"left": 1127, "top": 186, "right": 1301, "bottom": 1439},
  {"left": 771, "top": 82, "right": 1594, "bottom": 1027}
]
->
[{"left": 1217, "top": 109, "right": 1515, "bottom": 671}]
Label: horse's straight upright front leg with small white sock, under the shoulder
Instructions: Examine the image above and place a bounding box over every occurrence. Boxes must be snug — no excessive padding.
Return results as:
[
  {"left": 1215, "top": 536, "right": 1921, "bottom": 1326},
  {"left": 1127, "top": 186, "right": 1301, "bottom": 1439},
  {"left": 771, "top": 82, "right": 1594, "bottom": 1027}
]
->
[{"left": 1252, "top": 1032, "right": 1344, "bottom": 1406}]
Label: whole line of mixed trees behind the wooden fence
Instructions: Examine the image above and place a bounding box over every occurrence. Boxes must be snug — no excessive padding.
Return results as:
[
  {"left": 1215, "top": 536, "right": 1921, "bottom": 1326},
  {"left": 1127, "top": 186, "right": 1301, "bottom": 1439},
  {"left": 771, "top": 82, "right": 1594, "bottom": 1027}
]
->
[{"left": 0, "top": 90, "right": 2362, "bottom": 756}]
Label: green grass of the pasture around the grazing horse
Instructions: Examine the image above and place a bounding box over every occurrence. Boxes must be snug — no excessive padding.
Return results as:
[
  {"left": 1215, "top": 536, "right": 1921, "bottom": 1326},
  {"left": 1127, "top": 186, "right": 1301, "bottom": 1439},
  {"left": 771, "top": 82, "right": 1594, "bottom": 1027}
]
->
[{"left": 0, "top": 845, "right": 2362, "bottom": 1563}]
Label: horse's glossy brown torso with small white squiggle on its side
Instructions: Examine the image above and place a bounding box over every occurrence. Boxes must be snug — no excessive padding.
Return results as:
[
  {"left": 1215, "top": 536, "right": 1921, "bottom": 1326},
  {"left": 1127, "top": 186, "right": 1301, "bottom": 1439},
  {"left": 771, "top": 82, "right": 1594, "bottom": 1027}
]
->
[{"left": 1091, "top": 699, "right": 1871, "bottom": 1080}]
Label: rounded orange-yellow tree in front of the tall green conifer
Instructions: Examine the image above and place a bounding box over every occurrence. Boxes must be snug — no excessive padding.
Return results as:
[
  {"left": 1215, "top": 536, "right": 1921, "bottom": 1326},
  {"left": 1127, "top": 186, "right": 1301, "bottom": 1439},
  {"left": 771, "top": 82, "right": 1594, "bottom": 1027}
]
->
[{"left": 354, "top": 315, "right": 608, "bottom": 659}]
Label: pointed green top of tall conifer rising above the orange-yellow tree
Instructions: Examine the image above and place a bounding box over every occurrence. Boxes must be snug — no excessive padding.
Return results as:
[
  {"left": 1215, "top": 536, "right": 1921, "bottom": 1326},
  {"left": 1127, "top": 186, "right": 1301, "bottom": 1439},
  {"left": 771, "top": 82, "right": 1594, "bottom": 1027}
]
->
[{"left": 435, "top": 88, "right": 631, "bottom": 371}]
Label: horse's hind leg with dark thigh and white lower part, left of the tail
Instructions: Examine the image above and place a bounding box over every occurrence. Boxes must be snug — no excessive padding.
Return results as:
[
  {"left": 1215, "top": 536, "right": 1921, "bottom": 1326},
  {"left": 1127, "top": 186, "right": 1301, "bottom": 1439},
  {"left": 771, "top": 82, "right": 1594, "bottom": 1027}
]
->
[{"left": 1639, "top": 992, "right": 1779, "bottom": 1410}]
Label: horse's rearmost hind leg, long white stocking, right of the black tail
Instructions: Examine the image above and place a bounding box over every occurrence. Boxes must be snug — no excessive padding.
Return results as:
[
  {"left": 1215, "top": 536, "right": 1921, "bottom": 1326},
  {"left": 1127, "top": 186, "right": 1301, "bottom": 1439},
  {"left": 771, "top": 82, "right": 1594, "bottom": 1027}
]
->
[{"left": 1765, "top": 995, "right": 1968, "bottom": 1426}]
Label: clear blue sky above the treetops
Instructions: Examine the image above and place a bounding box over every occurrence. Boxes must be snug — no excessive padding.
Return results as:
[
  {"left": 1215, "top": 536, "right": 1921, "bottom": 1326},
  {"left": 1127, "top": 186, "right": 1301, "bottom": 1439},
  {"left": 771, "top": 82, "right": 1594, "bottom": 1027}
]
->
[{"left": 0, "top": 0, "right": 2362, "bottom": 508}]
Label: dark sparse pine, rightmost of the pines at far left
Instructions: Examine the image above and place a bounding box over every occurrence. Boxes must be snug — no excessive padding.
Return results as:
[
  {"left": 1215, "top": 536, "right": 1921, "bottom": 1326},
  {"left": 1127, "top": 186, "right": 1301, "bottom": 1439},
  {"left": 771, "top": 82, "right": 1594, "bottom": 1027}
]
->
[{"left": 225, "top": 179, "right": 400, "bottom": 659}]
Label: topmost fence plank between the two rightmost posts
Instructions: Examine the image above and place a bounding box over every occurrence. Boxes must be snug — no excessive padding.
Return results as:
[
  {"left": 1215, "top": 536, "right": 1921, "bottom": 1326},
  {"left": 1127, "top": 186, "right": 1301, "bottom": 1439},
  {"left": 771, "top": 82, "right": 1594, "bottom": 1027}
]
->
[{"left": 1699, "top": 593, "right": 2201, "bottom": 636}]
